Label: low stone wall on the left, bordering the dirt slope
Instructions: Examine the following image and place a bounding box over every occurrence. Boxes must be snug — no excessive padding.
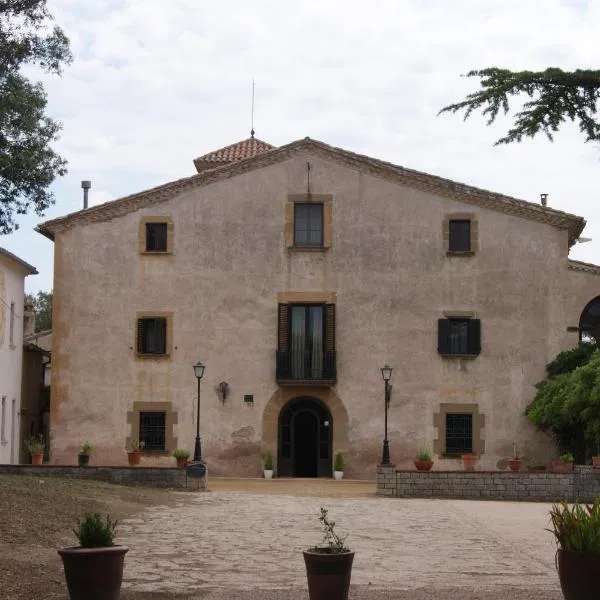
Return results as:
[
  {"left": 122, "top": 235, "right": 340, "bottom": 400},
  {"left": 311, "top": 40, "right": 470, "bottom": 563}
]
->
[{"left": 0, "top": 465, "right": 206, "bottom": 489}]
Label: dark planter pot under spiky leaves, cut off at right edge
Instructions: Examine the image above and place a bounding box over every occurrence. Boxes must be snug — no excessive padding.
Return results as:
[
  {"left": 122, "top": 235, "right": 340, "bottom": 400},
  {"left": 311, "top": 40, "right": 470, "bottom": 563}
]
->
[{"left": 558, "top": 550, "right": 600, "bottom": 600}]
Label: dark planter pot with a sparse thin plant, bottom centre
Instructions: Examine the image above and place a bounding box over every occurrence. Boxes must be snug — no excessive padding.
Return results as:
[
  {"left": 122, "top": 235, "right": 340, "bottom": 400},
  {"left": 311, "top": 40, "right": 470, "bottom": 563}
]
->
[{"left": 304, "top": 551, "right": 354, "bottom": 600}]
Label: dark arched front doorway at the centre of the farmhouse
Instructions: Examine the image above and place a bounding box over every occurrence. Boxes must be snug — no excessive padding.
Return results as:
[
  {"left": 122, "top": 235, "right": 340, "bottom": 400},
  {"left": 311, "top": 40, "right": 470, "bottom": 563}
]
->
[{"left": 277, "top": 397, "right": 333, "bottom": 477}]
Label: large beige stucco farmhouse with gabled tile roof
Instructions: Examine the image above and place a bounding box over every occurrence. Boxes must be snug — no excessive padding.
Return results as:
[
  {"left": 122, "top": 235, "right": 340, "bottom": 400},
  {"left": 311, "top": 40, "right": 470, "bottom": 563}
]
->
[{"left": 38, "top": 137, "right": 600, "bottom": 477}]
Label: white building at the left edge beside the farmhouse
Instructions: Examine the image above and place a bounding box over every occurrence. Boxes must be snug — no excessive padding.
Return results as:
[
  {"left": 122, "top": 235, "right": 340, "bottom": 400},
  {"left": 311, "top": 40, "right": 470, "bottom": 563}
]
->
[{"left": 0, "top": 248, "right": 37, "bottom": 464}]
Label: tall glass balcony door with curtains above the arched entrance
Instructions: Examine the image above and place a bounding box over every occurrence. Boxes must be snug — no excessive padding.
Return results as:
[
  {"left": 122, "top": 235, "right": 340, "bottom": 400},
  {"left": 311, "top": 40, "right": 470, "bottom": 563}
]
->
[{"left": 290, "top": 304, "right": 324, "bottom": 379}]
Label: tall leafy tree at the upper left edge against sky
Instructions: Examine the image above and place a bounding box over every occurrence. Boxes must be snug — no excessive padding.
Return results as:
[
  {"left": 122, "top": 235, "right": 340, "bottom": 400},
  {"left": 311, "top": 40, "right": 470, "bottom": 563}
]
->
[{"left": 0, "top": 0, "right": 71, "bottom": 234}]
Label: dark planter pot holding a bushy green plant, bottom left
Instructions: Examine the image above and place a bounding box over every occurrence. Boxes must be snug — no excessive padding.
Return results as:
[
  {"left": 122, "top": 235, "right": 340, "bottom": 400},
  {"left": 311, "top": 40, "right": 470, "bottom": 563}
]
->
[{"left": 58, "top": 546, "right": 129, "bottom": 600}]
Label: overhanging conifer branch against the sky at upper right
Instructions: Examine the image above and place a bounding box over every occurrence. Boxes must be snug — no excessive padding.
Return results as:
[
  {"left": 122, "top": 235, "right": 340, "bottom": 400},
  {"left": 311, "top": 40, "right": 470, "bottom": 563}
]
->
[{"left": 438, "top": 67, "right": 600, "bottom": 145}]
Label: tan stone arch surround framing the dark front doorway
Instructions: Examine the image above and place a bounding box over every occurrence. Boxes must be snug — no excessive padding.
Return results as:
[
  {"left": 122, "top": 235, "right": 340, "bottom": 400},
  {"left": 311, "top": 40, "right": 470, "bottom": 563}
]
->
[{"left": 262, "top": 385, "right": 349, "bottom": 470}]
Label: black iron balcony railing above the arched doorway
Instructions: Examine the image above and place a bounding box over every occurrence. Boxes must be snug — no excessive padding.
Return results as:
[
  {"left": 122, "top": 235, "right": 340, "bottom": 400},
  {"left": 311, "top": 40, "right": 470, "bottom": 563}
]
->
[{"left": 276, "top": 351, "right": 336, "bottom": 385}]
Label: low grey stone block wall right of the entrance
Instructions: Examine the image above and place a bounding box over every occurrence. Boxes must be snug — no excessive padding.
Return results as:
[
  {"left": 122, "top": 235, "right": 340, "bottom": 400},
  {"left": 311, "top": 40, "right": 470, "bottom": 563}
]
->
[{"left": 377, "top": 466, "right": 600, "bottom": 502}]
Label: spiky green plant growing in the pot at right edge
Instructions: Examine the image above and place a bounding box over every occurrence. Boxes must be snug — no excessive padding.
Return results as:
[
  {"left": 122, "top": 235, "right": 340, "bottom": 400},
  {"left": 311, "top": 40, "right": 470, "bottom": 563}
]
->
[{"left": 547, "top": 498, "right": 600, "bottom": 554}]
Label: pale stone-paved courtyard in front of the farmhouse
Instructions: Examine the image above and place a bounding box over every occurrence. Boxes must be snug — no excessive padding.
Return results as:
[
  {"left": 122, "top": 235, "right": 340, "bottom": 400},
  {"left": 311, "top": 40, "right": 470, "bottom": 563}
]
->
[{"left": 118, "top": 480, "right": 562, "bottom": 600}]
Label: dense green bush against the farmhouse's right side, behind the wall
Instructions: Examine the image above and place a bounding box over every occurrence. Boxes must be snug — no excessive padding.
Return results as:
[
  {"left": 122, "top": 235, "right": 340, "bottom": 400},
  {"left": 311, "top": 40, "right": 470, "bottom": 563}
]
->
[{"left": 526, "top": 344, "right": 600, "bottom": 461}]
